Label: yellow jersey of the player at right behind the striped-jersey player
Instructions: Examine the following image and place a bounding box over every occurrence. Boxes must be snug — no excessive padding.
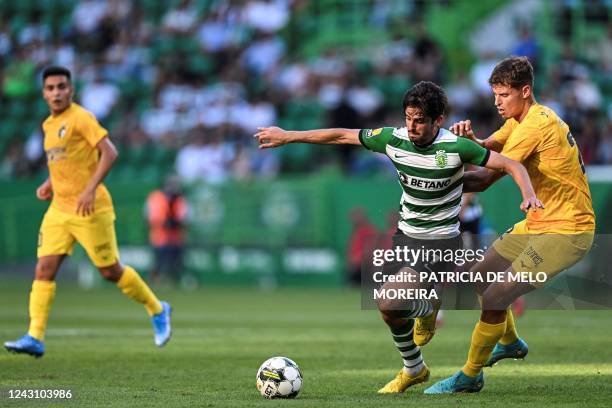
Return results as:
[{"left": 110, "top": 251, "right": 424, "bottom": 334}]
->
[{"left": 493, "top": 104, "right": 595, "bottom": 233}]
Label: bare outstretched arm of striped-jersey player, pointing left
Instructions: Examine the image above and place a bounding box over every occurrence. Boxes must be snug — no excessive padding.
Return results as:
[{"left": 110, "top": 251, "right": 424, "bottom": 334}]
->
[{"left": 253, "top": 126, "right": 360, "bottom": 149}]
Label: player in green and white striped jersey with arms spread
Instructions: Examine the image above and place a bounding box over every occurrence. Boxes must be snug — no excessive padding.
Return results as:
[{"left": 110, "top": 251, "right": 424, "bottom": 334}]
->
[{"left": 254, "top": 82, "right": 542, "bottom": 393}]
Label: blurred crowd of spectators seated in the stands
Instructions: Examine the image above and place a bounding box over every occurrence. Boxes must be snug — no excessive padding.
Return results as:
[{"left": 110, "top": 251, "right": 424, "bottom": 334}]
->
[{"left": 0, "top": 0, "right": 612, "bottom": 183}]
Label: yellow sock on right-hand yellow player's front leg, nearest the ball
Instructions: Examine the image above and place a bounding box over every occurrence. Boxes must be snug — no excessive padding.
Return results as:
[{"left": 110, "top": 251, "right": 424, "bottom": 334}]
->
[{"left": 462, "top": 320, "right": 506, "bottom": 377}]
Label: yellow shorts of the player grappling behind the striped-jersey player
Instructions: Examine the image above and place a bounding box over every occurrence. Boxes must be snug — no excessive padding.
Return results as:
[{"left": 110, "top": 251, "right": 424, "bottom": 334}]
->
[{"left": 493, "top": 220, "right": 594, "bottom": 287}]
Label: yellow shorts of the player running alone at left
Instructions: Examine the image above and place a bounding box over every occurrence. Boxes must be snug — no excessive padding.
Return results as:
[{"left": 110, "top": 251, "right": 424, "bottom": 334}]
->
[{"left": 37, "top": 207, "right": 119, "bottom": 267}]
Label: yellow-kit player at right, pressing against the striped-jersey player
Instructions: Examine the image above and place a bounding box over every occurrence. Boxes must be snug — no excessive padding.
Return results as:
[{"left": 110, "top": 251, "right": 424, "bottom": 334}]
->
[{"left": 425, "top": 57, "right": 595, "bottom": 394}]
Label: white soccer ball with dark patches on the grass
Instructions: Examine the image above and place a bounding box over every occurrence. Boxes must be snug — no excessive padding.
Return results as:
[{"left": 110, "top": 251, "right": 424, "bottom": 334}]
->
[{"left": 257, "top": 357, "right": 303, "bottom": 398}]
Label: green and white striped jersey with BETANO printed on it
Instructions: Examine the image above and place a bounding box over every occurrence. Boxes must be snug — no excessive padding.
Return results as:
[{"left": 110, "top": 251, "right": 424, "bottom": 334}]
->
[{"left": 359, "top": 127, "right": 491, "bottom": 239}]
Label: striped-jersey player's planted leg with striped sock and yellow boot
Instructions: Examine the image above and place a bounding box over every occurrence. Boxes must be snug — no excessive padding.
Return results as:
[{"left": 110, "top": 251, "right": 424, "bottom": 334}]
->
[{"left": 377, "top": 268, "right": 433, "bottom": 394}]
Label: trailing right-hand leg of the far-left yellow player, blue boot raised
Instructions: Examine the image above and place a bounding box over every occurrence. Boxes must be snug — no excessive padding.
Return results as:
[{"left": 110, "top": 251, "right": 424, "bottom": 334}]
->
[{"left": 70, "top": 212, "right": 171, "bottom": 347}]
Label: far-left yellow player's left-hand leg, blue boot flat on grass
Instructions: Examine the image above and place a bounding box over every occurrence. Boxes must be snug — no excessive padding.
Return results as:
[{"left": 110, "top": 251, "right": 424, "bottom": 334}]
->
[{"left": 4, "top": 208, "right": 74, "bottom": 357}]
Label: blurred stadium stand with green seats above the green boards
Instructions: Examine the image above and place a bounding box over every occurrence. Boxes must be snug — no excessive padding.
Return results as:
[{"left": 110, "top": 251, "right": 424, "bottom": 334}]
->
[{"left": 0, "top": 0, "right": 612, "bottom": 182}]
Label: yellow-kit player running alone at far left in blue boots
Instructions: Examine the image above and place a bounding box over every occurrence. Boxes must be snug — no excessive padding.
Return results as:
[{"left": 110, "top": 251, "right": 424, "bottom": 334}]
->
[{"left": 4, "top": 67, "right": 171, "bottom": 357}]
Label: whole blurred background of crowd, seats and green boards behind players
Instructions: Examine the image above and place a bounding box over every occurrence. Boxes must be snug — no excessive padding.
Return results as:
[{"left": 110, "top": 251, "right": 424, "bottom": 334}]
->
[{"left": 0, "top": 0, "right": 612, "bottom": 288}]
